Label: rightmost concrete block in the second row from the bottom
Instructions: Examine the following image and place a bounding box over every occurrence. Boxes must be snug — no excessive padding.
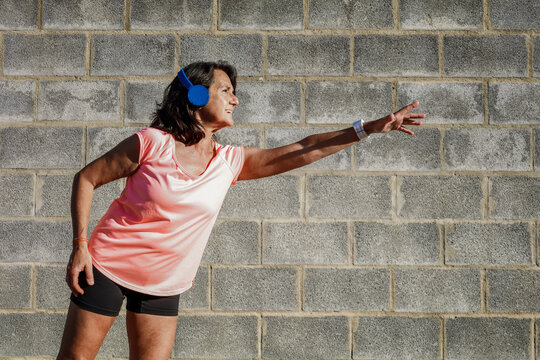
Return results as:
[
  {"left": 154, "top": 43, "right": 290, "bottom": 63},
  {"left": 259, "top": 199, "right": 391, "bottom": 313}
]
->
[{"left": 487, "top": 269, "right": 540, "bottom": 313}]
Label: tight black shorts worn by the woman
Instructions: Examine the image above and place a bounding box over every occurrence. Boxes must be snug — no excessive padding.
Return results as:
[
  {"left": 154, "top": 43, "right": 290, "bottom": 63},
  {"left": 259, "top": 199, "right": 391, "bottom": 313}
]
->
[{"left": 71, "top": 266, "right": 180, "bottom": 316}]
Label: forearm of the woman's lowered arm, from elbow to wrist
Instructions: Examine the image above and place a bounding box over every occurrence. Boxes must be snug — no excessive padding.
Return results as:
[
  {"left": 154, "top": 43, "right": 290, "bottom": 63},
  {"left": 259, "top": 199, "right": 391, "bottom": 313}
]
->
[{"left": 71, "top": 172, "right": 94, "bottom": 245}]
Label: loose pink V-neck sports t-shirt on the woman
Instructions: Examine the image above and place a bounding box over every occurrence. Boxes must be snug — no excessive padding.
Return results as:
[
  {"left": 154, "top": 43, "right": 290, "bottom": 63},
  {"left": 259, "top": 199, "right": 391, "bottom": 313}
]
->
[{"left": 89, "top": 128, "right": 244, "bottom": 296}]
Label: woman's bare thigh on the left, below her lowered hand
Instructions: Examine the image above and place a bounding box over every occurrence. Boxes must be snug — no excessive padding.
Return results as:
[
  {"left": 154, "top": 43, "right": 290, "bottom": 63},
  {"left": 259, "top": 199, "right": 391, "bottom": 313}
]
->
[{"left": 56, "top": 303, "right": 116, "bottom": 360}]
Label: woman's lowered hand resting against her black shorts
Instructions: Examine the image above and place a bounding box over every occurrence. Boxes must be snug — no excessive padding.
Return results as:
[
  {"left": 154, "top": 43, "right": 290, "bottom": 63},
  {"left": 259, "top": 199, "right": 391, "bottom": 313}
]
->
[{"left": 66, "top": 242, "right": 94, "bottom": 296}]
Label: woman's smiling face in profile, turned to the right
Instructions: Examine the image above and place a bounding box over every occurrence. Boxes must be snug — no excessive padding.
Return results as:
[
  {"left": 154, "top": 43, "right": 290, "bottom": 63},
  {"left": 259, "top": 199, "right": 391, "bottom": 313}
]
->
[{"left": 195, "top": 70, "right": 238, "bottom": 131}]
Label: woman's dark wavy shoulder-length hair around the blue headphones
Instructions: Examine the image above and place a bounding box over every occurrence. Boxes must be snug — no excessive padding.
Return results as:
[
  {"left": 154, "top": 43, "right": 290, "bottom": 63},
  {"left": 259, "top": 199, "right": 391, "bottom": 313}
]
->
[{"left": 150, "top": 61, "right": 236, "bottom": 146}]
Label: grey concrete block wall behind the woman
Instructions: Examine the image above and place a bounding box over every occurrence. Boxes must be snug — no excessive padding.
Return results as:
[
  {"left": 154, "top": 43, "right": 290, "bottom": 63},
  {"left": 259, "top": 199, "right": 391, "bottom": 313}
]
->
[{"left": 0, "top": 0, "right": 540, "bottom": 360}]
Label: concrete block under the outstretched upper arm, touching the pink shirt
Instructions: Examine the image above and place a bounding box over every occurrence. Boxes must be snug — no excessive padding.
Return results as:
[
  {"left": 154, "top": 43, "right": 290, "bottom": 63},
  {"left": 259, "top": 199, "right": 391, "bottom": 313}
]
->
[{"left": 219, "top": 175, "right": 300, "bottom": 219}]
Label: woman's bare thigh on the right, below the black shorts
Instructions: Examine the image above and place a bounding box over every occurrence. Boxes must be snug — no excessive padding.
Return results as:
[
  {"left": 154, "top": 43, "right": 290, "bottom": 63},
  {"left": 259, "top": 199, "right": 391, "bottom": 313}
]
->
[{"left": 126, "top": 310, "right": 178, "bottom": 360}]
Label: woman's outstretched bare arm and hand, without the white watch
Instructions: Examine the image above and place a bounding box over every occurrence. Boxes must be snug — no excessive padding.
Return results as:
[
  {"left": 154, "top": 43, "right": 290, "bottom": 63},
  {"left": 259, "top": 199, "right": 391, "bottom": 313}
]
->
[{"left": 239, "top": 102, "right": 425, "bottom": 180}]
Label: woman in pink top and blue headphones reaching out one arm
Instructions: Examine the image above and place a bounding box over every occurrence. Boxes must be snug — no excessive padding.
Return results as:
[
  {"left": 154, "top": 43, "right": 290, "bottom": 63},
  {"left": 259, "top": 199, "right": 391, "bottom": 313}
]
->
[{"left": 58, "top": 62, "right": 425, "bottom": 360}]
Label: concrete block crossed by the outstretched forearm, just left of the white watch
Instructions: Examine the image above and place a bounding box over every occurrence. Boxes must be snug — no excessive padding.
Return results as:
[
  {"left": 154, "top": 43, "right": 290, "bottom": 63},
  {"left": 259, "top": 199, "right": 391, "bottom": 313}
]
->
[{"left": 265, "top": 127, "right": 352, "bottom": 170}]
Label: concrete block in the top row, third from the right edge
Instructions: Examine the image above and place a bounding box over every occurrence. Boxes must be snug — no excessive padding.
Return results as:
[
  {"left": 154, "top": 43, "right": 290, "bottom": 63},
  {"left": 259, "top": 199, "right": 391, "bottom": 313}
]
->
[{"left": 309, "top": 0, "right": 394, "bottom": 29}]
